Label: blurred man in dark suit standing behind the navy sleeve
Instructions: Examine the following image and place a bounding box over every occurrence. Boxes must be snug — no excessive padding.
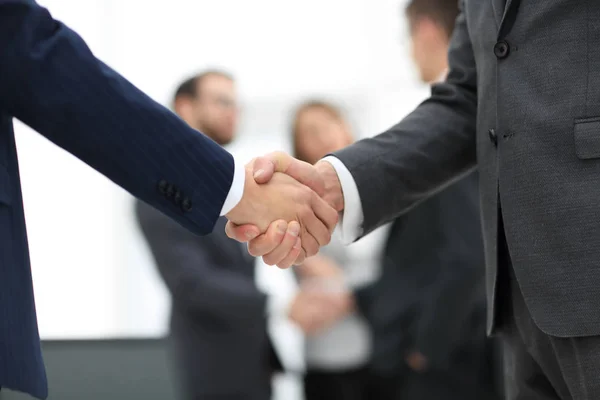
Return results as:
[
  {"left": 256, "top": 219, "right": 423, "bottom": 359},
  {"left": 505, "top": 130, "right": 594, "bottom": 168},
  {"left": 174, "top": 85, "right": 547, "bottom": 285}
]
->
[{"left": 136, "top": 70, "right": 344, "bottom": 400}]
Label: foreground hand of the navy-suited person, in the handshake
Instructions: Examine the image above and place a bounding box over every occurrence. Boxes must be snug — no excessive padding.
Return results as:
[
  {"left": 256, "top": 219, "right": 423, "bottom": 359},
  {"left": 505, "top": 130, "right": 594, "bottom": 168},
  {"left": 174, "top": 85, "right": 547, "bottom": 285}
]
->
[{"left": 226, "top": 163, "right": 338, "bottom": 255}]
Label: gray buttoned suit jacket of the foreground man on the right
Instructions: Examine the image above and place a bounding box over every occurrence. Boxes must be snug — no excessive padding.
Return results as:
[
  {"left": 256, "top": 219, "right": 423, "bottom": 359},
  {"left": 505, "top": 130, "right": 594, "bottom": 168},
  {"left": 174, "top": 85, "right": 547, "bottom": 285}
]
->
[{"left": 336, "top": 0, "right": 600, "bottom": 337}]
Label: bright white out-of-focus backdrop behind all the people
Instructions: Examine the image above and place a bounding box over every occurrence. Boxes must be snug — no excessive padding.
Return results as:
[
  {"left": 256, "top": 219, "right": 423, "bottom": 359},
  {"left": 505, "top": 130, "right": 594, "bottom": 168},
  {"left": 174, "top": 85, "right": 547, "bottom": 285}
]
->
[{"left": 7, "top": 0, "right": 429, "bottom": 399}]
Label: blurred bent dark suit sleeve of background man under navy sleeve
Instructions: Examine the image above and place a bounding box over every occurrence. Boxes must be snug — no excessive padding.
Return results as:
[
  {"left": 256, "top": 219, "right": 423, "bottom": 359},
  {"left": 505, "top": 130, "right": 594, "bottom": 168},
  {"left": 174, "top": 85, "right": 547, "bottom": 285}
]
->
[{"left": 136, "top": 202, "right": 267, "bottom": 324}]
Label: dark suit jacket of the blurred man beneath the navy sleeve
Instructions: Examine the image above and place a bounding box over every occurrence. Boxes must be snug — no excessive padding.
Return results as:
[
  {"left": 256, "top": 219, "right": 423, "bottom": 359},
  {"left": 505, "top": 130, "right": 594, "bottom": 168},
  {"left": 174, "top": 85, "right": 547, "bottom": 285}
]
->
[{"left": 136, "top": 206, "right": 281, "bottom": 400}]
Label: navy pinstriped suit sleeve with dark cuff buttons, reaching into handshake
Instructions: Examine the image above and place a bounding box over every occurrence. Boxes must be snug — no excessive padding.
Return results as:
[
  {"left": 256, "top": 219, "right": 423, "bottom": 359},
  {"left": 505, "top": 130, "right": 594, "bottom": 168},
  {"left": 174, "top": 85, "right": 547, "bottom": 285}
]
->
[{"left": 0, "top": 0, "right": 234, "bottom": 234}]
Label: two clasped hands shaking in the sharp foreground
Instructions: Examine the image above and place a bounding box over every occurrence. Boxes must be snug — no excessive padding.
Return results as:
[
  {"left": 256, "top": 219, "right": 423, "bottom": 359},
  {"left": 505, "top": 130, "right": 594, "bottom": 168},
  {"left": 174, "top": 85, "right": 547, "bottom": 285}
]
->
[{"left": 226, "top": 152, "right": 344, "bottom": 268}]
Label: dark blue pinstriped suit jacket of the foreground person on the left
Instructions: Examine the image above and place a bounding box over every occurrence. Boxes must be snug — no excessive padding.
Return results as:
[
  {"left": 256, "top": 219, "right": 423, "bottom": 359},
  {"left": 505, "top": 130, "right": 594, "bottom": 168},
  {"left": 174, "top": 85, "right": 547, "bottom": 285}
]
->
[{"left": 0, "top": 0, "right": 234, "bottom": 398}]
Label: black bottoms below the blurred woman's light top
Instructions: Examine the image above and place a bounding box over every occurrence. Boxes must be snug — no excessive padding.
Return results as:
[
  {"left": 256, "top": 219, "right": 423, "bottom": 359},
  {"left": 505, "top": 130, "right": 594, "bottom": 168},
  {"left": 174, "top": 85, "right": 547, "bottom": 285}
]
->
[{"left": 304, "top": 368, "right": 377, "bottom": 400}]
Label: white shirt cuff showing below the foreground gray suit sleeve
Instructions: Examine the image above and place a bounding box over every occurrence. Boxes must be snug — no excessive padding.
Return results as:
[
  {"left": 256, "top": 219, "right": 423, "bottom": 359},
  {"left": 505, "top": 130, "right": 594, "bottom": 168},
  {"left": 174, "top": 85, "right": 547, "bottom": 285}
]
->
[{"left": 323, "top": 156, "right": 364, "bottom": 245}]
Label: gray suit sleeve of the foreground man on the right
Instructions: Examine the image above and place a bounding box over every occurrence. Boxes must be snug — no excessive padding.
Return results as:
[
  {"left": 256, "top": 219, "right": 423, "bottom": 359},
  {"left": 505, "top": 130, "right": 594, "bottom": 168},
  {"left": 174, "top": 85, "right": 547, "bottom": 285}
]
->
[{"left": 333, "top": 0, "right": 477, "bottom": 235}]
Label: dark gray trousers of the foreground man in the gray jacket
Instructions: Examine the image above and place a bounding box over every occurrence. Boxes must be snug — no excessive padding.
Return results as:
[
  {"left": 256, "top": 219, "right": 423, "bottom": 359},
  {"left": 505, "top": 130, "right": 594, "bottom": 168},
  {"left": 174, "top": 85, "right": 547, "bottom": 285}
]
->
[{"left": 498, "top": 223, "right": 600, "bottom": 400}]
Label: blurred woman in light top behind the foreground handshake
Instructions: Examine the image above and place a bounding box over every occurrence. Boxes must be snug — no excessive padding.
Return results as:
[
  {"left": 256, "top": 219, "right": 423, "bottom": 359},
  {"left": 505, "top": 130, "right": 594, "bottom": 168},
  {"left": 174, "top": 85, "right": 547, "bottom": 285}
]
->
[{"left": 292, "top": 101, "right": 385, "bottom": 400}]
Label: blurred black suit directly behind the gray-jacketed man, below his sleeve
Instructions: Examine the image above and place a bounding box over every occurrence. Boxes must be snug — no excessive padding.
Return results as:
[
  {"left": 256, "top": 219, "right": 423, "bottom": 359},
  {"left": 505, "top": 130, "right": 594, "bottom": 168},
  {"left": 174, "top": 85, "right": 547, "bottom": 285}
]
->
[{"left": 356, "top": 172, "right": 496, "bottom": 400}]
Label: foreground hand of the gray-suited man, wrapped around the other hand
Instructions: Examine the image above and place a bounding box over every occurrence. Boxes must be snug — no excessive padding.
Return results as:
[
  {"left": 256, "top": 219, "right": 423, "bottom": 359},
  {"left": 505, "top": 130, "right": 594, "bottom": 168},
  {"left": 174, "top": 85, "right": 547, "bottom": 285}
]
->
[{"left": 226, "top": 152, "right": 344, "bottom": 268}]
